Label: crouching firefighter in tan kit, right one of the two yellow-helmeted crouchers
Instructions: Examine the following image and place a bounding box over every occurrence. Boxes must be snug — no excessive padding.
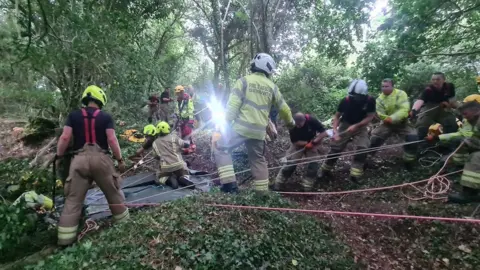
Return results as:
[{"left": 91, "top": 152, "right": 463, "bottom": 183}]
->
[{"left": 153, "top": 122, "right": 195, "bottom": 189}]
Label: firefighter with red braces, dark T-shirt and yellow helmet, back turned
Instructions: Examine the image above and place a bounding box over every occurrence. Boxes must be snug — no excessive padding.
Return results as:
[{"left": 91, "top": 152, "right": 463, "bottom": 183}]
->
[{"left": 57, "top": 85, "right": 129, "bottom": 246}]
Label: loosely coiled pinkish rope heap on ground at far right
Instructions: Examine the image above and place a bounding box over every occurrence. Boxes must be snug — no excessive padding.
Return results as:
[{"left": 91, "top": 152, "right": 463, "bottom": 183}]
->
[{"left": 403, "top": 142, "right": 464, "bottom": 201}]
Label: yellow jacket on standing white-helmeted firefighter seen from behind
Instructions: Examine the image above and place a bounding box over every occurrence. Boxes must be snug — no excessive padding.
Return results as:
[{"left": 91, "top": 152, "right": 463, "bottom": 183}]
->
[{"left": 226, "top": 73, "right": 295, "bottom": 140}]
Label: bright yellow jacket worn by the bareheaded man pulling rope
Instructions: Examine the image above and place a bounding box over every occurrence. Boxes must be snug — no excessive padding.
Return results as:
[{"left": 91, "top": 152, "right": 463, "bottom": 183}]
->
[{"left": 377, "top": 89, "right": 410, "bottom": 124}]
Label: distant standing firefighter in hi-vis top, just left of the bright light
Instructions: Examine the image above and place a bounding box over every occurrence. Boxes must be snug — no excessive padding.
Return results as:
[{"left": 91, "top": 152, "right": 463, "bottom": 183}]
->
[{"left": 175, "top": 85, "right": 195, "bottom": 154}]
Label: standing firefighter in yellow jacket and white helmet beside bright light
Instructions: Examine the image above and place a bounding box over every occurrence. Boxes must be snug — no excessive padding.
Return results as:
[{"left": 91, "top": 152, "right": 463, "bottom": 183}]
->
[{"left": 214, "top": 53, "right": 295, "bottom": 193}]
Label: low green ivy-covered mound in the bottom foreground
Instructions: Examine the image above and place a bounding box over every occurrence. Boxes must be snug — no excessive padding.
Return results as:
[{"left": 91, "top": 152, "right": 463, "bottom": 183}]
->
[{"left": 27, "top": 192, "right": 356, "bottom": 269}]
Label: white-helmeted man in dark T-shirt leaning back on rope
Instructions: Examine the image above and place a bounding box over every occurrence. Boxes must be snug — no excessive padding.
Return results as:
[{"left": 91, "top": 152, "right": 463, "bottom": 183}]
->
[{"left": 319, "top": 80, "right": 376, "bottom": 183}]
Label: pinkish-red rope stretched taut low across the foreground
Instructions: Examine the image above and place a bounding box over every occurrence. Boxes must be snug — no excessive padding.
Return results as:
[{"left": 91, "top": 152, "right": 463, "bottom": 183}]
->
[{"left": 206, "top": 204, "right": 480, "bottom": 224}]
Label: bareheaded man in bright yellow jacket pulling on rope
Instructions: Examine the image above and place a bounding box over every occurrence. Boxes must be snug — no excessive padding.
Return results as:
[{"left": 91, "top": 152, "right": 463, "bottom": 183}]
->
[{"left": 370, "top": 79, "right": 418, "bottom": 169}]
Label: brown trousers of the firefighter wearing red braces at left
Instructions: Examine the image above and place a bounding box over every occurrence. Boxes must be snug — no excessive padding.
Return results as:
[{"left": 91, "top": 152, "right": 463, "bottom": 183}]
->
[{"left": 58, "top": 144, "right": 129, "bottom": 245}]
